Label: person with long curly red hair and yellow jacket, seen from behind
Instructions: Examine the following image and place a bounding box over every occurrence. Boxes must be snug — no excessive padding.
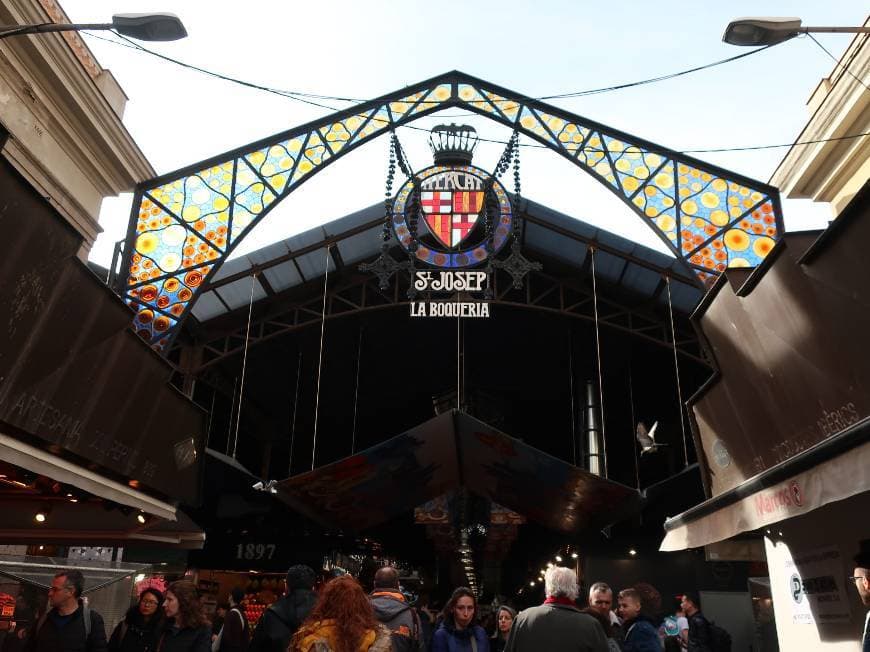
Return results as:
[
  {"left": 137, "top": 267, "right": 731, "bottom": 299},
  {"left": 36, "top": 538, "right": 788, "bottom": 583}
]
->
[{"left": 290, "top": 575, "right": 393, "bottom": 652}]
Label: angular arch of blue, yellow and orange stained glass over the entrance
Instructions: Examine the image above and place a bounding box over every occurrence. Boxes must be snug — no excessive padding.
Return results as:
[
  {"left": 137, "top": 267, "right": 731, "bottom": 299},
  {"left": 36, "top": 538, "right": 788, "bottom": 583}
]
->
[{"left": 116, "top": 71, "right": 783, "bottom": 352}]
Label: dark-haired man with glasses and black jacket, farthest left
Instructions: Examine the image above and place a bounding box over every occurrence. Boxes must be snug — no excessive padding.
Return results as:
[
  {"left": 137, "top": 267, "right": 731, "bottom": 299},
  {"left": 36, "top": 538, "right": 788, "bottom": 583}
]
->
[{"left": 27, "top": 570, "right": 107, "bottom": 652}]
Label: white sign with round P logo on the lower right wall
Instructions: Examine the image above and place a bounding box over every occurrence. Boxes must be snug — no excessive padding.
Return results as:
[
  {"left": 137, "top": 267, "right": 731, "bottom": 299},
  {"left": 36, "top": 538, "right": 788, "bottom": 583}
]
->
[{"left": 783, "top": 546, "right": 852, "bottom": 625}]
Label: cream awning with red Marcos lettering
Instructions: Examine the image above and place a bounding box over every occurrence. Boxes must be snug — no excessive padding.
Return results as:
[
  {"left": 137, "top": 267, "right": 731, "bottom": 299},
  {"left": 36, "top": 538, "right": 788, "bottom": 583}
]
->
[{"left": 660, "top": 417, "right": 870, "bottom": 551}]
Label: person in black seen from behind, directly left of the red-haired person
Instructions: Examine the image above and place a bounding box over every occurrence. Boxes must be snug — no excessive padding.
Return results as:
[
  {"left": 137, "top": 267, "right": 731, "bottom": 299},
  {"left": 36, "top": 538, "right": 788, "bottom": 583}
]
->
[{"left": 248, "top": 564, "right": 317, "bottom": 652}]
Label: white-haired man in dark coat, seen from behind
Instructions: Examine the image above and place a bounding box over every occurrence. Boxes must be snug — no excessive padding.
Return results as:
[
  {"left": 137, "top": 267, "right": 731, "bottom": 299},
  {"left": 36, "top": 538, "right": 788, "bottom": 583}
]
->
[{"left": 505, "top": 566, "right": 607, "bottom": 652}]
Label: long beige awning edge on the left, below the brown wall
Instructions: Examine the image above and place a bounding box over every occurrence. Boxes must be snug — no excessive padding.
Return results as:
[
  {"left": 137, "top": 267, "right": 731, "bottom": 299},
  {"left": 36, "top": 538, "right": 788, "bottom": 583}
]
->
[{"left": 0, "top": 433, "right": 176, "bottom": 521}]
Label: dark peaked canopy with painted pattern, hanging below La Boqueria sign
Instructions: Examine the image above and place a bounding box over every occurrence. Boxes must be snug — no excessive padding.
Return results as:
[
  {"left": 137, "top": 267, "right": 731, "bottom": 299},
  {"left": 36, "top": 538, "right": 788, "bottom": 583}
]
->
[{"left": 277, "top": 411, "right": 640, "bottom": 533}]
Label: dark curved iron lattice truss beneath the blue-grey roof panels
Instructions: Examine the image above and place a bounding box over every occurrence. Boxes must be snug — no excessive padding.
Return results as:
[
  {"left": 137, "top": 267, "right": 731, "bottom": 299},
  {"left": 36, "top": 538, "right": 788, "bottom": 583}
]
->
[{"left": 191, "top": 268, "right": 710, "bottom": 375}]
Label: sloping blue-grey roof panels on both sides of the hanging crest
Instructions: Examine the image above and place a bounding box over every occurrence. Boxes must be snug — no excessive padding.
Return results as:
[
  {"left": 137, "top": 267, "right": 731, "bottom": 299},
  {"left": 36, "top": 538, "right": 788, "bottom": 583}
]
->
[{"left": 192, "top": 200, "right": 703, "bottom": 322}]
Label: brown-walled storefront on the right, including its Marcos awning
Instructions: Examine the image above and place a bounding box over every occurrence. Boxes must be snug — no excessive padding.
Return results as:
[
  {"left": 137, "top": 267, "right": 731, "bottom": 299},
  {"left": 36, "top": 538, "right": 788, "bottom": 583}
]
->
[{"left": 661, "top": 184, "right": 870, "bottom": 650}]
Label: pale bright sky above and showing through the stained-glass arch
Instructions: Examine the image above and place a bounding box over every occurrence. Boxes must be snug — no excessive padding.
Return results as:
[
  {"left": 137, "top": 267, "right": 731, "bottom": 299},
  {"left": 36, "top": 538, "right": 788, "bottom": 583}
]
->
[{"left": 62, "top": 0, "right": 866, "bottom": 265}]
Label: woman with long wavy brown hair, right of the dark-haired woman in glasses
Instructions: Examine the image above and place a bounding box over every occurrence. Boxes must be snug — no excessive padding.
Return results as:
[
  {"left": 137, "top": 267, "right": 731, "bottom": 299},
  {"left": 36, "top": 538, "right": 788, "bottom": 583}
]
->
[{"left": 157, "top": 580, "right": 211, "bottom": 652}]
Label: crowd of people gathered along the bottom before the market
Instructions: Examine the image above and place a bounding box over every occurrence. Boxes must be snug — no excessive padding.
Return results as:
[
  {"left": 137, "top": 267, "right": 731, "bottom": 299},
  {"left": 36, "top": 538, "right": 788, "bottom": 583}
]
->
[{"left": 11, "top": 558, "right": 870, "bottom": 652}]
